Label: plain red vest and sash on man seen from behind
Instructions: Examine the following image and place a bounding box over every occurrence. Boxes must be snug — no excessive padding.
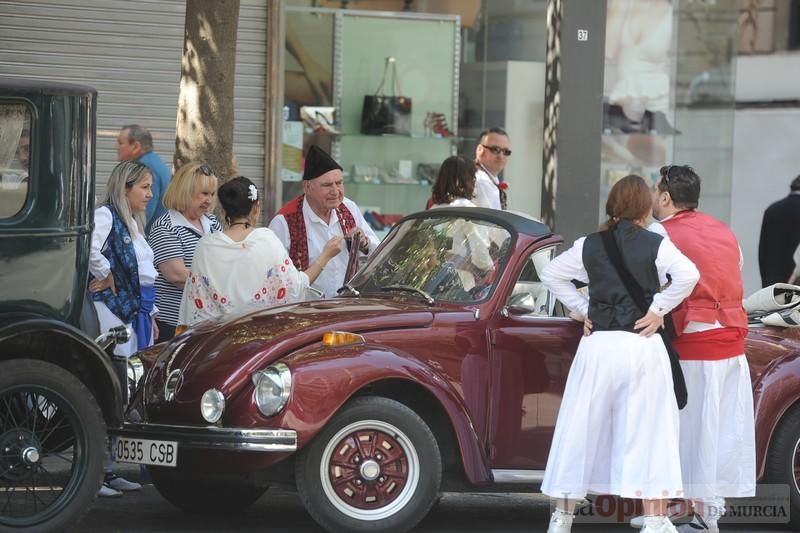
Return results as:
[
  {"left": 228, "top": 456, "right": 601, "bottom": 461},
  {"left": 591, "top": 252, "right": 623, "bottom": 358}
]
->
[{"left": 662, "top": 210, "right": 747, "bottom": 359}]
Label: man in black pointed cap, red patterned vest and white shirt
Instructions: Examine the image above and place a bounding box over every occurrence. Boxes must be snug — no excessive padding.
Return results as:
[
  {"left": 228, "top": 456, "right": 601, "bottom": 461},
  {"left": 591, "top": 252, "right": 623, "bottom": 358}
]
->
[{"left": 269, "top": 146, "right": 380, "bottom": 298}]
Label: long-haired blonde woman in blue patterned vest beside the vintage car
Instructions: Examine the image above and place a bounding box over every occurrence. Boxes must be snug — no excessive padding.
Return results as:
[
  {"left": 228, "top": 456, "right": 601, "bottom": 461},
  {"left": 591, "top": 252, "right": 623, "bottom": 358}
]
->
[{"left": 89, "top": 161, "right": 158, "bottom": 357}]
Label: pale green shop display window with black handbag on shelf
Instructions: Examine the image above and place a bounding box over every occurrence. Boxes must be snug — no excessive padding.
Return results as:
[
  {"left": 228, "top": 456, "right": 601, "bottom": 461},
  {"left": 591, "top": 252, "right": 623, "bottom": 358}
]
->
[{"left": 281, "top": 7, "right": 459, "bottom": 236}]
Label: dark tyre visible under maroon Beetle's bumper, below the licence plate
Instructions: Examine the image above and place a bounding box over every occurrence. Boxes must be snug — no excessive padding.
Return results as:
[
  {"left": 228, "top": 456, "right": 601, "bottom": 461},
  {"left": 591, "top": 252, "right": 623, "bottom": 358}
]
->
[{"left": 147, "top": 466, "right": 268, "bottom": 514}]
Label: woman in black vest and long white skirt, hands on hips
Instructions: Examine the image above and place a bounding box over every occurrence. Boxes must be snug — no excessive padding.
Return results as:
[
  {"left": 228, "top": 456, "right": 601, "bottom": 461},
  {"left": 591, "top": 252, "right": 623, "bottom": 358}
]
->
[{"left": 541, "top": 175, "right": 700, "bottom": 533}]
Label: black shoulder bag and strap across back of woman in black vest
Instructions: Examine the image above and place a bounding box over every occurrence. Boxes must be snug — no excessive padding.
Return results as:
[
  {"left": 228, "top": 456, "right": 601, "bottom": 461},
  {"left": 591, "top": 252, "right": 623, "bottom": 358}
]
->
[{"left": 600, "top": 230, "right": 688, "bottom": 409}]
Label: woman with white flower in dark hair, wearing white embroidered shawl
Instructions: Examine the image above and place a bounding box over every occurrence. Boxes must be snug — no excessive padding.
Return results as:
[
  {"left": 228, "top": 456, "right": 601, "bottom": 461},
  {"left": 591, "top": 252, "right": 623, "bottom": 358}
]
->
[{"left": 178, "top": 176, "right": 342, "bottom": 326}]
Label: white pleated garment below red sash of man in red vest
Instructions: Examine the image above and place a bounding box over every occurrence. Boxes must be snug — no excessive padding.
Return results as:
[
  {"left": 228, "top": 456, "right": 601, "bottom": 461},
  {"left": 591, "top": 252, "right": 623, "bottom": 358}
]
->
[{"left": 680, "top": 355, "right": 756, "bottom": 499}]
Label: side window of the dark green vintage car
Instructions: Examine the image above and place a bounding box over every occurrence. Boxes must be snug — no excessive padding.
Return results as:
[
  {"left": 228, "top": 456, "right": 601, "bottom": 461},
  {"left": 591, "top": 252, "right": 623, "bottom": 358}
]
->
[{"left": 0, "top": 103, "right": 31, "bottom": 219}]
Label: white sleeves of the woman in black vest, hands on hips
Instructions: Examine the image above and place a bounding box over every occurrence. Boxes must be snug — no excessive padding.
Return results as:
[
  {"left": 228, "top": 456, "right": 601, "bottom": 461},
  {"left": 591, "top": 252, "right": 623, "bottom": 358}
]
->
[{"left": 540, "top": 230, "right": 700, "bottom": 316}]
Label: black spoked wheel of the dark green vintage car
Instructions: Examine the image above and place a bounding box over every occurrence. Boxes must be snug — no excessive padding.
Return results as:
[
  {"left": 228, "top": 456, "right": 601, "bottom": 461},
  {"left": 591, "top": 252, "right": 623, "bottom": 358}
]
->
[{"left": 0, "top": 359, "right": 106, "bottom": 532}]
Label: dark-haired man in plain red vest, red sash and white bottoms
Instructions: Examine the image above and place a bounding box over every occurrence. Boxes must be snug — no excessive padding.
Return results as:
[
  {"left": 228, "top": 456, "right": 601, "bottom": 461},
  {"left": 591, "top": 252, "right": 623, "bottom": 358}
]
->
[{"left": 651, "top": 165, "right": 756, "bottom": 532}]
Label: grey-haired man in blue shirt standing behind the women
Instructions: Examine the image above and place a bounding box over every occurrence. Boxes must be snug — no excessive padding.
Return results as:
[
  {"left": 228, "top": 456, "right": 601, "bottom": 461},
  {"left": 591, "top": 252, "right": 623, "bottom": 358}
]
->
[{"left": 117, "top": 124, "right": 172, "bottom": 235}]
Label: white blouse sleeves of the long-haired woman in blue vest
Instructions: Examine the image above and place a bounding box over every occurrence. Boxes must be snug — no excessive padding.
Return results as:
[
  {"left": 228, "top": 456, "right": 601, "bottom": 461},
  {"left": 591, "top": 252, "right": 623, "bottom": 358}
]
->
[{"left": 89, "top": 206, "right": 158, "bottom": 287}]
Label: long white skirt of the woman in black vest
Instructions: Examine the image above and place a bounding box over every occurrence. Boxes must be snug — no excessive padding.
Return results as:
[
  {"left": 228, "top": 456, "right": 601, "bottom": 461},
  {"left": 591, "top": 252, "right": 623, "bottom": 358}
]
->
[{"left": 542, "top": 331, "right": 683, "bottom": 499}]
